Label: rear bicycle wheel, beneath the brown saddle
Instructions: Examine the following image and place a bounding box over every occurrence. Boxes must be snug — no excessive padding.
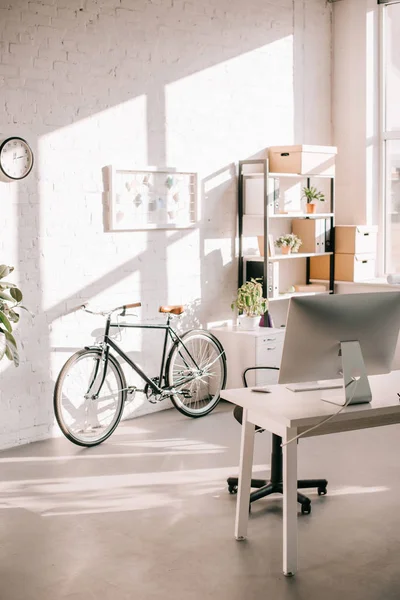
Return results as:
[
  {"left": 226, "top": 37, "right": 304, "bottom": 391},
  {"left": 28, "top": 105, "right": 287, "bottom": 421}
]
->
[{"left": 166, "top": 329, "right": 226, "bottom": 417}]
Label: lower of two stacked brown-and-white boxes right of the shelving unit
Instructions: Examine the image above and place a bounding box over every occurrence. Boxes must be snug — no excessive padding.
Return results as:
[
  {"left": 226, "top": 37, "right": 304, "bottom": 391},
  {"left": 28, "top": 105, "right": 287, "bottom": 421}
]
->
[{"left": 310, "top": 254, "right": 375, "bottom": 282}]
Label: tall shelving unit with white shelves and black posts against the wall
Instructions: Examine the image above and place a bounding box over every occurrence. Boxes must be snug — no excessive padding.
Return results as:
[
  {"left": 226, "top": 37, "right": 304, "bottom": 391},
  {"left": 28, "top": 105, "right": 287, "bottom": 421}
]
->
[{"left": 238, "top": 154, "right": 334, "bottom": 294}]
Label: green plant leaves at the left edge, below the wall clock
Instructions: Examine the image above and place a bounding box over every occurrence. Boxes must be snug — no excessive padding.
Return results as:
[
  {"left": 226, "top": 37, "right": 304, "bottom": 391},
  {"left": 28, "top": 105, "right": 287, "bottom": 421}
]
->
[{"left": 0, "top": 265, "right": 27, "bottom": 367}]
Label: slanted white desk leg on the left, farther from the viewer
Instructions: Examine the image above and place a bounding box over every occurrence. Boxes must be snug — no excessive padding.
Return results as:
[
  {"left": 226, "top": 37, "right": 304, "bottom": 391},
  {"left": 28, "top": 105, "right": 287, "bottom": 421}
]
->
[{"left": 235, "top": 410, "right": 255, "bottom": 541}]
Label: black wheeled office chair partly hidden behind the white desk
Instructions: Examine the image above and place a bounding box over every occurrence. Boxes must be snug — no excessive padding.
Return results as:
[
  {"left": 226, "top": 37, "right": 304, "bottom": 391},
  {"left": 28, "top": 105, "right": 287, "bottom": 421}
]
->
[{"left": 227, "top": 367, "right": 328, "bottom": 515}]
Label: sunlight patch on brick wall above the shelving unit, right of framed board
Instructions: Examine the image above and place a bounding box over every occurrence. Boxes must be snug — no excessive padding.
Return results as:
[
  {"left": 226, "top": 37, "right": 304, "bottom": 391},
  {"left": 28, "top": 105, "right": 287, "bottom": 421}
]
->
[{"left": 165, "top": 35, "right": 294, "bottom": 172}]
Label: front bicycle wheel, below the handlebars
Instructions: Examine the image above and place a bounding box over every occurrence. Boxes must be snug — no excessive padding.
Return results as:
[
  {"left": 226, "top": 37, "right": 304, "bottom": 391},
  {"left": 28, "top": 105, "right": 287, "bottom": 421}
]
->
[{"left": 54, "top": 348, "right": 126, "bottom": 446}]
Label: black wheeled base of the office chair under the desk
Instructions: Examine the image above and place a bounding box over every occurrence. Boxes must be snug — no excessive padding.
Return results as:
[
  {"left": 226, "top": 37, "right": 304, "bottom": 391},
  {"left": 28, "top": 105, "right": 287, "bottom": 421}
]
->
[{"left": 227, "top": 477, "right": 328, "bottom": 514}]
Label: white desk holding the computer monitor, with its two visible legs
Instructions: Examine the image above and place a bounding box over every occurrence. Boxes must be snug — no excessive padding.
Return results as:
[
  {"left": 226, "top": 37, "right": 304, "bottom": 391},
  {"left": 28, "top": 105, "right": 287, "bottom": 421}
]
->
[{"left": 221, "top": 371, "right": 400, "bottom": 575}]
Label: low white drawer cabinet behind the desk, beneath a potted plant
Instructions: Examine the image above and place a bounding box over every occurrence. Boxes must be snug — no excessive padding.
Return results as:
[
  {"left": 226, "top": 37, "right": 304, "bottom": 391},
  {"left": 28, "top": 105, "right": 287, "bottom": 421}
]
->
[{"left": 210, "top": 325, "right": 285, "bottom": 389}]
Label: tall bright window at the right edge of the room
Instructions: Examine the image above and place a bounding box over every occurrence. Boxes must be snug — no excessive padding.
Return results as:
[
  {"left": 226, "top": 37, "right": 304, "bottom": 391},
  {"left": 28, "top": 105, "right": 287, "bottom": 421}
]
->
[{"left": 382, "top": 3, "right": 400, "bottom": 273}]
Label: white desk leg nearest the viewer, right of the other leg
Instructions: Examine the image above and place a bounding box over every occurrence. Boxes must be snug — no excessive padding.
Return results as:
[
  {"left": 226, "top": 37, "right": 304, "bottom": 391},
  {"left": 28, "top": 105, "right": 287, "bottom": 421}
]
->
[{"left": 283, "top": 428, "right": 297, "bottom": 577}]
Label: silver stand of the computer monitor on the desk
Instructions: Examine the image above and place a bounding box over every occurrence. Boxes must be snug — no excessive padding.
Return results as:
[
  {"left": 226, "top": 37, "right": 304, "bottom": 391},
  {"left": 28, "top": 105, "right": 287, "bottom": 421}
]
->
[{"left": 321, "top": 342, "right": 372, "bottom": 406}]
